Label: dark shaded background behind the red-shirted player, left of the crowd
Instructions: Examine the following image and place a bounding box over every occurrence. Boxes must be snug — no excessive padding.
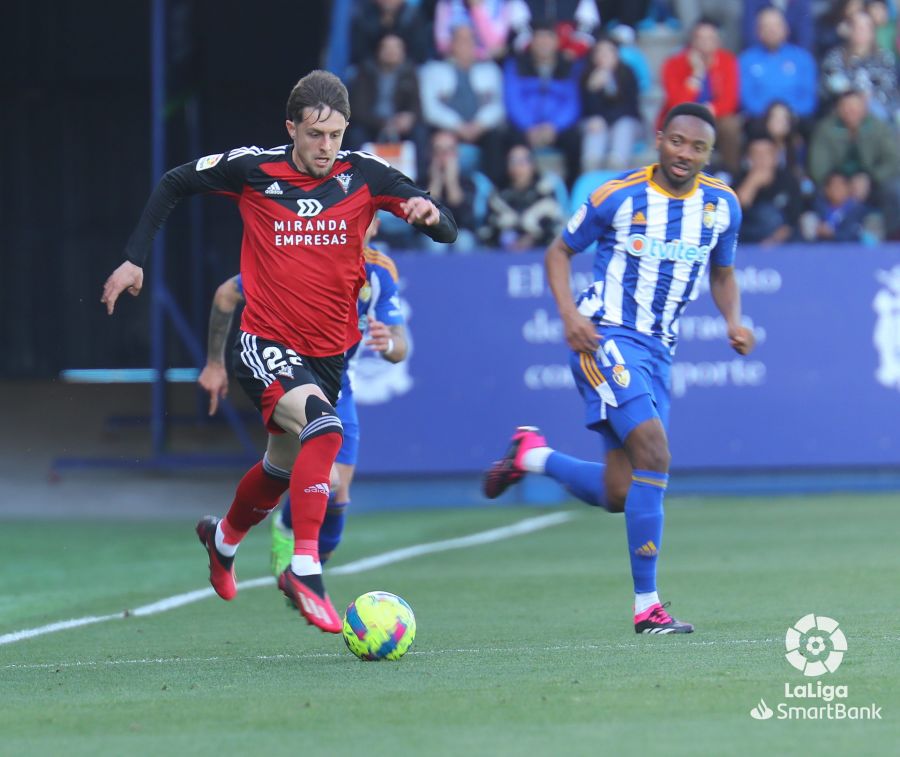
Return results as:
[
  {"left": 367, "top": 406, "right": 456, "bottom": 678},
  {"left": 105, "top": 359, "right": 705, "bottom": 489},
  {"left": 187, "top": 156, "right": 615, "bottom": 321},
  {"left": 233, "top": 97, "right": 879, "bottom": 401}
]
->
[{"left": 0, "top": 0, "right": 330, "bottom": 378}]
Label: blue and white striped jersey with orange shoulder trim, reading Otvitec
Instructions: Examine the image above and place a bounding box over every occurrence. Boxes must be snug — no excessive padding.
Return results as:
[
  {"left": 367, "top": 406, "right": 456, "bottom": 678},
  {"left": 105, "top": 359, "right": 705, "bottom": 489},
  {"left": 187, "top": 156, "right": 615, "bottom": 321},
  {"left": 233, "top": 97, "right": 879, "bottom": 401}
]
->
[{"left": 562, "top": 165, "right": 741, "bottom": 347}]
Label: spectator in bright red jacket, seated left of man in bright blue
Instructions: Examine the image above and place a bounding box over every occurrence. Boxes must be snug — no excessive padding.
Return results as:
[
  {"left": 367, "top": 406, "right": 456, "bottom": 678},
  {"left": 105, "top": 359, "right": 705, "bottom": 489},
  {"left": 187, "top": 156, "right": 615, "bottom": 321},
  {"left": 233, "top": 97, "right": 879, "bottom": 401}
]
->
[{"left": 658, "top": 18, "right": 741, "bottom": 175}]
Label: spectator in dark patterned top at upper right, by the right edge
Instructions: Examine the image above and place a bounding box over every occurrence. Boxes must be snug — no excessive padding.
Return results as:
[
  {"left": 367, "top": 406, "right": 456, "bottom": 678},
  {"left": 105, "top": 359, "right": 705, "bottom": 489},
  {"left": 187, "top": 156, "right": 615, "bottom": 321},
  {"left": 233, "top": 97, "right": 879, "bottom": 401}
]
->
[{"left": 821, "top": 11, "right": 900, "bottom": 123}]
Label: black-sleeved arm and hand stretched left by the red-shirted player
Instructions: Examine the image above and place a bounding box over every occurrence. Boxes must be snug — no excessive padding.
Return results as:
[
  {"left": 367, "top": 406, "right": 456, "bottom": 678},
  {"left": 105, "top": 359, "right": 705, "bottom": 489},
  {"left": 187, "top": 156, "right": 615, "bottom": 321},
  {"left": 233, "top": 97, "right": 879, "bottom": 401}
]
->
[{"left": 100, "top": 153, "right": 241, "bottom": 315}]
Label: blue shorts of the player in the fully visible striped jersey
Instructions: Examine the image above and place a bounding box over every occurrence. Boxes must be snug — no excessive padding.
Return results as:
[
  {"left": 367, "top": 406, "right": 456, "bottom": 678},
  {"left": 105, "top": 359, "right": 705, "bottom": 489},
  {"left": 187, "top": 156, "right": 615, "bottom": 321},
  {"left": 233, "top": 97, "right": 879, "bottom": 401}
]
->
[{"left": 569, "top": 326, "right": 672, "bottom": 450}]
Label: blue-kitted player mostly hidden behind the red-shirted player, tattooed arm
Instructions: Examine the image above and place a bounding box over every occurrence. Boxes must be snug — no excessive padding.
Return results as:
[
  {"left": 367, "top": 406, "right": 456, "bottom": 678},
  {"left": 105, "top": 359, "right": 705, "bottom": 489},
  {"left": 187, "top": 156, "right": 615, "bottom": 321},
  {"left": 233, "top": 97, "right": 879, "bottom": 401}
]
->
[{"left": 198, "top": 216, "right": 408, "bottom": 576}]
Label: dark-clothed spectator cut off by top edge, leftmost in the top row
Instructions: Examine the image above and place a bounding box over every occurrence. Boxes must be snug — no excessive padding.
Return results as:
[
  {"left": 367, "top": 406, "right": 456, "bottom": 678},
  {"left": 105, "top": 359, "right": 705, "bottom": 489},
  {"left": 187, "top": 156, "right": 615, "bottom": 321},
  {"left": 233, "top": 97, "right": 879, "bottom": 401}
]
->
[{"left": 350, "top": 0, "right": 432, "bottom": 64}]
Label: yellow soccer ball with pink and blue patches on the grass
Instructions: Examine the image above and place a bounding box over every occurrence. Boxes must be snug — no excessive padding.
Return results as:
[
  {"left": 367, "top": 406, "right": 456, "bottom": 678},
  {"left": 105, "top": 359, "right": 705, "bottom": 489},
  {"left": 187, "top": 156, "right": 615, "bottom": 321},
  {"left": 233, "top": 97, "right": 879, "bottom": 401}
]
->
[{"left": 343, "top": 591, "right": 416, "bottom": 660}]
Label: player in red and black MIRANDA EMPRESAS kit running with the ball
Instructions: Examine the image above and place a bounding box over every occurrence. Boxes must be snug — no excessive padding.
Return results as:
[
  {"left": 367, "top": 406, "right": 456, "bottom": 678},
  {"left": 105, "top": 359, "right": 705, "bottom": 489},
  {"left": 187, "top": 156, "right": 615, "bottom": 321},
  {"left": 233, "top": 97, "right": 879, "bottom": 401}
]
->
[{"left": 101, "top": 71, "right": 456, "bottom": 633}]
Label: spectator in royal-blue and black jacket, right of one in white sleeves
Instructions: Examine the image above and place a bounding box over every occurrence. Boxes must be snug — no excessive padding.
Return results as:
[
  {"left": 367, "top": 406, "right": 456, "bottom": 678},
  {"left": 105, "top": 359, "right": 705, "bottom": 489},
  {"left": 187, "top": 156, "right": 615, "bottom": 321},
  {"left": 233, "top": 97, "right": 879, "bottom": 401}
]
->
[{"left": 503, "top": 22, "right": 581, "bottom": 181}]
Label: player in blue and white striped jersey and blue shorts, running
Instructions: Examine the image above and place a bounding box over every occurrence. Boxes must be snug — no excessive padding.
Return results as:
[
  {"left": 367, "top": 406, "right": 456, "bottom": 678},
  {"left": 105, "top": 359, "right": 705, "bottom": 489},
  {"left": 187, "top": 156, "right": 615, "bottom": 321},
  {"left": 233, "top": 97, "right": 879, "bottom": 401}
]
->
[{"left": 484, "top": 103, "right": 754, "bottom": 634}]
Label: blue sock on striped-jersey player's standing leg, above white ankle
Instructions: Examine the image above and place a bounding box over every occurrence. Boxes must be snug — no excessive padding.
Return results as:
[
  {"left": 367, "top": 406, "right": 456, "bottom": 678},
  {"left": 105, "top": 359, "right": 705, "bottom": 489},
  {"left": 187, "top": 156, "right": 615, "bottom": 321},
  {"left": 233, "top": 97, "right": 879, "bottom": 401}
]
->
[{"left": 625, "top": 470, "right": 669, "bottom": 594}]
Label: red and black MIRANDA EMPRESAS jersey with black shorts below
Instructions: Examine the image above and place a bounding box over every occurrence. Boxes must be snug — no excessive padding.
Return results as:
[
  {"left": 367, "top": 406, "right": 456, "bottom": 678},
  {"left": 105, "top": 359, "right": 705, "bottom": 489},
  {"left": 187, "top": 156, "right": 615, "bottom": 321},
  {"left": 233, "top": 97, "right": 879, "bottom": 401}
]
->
[{"left": 125, "top": 144, "right": 456, "bottom": 422}]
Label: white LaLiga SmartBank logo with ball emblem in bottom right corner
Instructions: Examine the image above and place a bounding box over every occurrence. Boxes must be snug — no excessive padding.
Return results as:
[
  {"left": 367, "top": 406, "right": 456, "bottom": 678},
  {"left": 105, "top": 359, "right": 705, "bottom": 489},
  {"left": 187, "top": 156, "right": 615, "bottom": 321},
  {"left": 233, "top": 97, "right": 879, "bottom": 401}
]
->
[{"left": 750, "top": 613, "right": 881, "bottom": 720}]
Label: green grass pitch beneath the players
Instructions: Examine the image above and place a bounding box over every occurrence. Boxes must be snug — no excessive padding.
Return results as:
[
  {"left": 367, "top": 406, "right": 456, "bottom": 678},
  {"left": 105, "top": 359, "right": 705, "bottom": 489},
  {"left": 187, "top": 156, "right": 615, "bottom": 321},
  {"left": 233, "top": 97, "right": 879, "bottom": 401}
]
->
[{"left": 0, "top": 495, "right": 900, "bottom": 757}]
